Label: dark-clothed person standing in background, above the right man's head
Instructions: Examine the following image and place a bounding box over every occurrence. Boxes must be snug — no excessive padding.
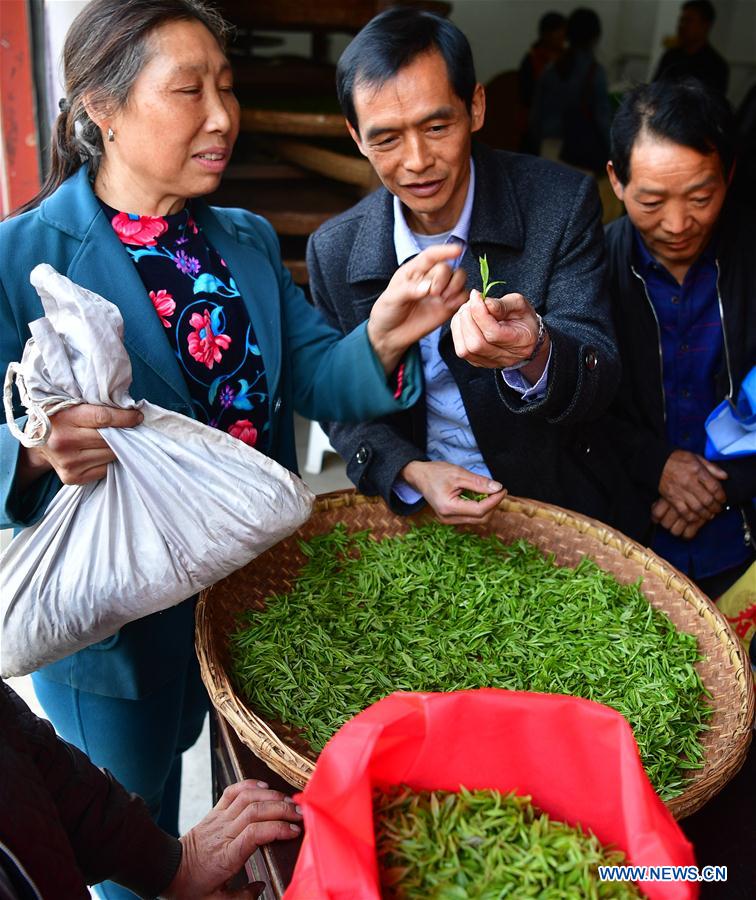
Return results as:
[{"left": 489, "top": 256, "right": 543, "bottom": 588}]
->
[{"left": 654, "top": 0, "right": 730, "bottom": 94}]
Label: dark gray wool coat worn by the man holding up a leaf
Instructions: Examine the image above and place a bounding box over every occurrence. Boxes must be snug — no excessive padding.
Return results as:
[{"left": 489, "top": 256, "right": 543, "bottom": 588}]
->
[{"left": 307, "top": 137, "right": 647, "bottom": 536}]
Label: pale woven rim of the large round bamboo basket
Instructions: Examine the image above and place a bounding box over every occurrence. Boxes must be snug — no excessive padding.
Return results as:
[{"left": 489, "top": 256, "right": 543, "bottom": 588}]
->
[{"left": 196, "top": 489, "right": 756, "bottom": 819}]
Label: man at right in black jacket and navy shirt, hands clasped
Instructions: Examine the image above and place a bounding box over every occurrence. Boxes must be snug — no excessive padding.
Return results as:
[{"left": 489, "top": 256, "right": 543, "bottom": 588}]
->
[{"left": 606, "top": 79, "right": 756, "bottom": 597}]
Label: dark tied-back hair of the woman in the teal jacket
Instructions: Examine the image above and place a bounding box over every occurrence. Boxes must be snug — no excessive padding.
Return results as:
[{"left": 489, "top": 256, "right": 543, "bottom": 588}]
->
[{"left": 16, "top": 0, "right": 228, "bottom": 213}]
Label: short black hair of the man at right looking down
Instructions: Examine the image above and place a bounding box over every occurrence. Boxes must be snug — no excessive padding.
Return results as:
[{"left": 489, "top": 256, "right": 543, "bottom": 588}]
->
[{"left": 610, "top": 78, "right": 735, "bottom": 185}]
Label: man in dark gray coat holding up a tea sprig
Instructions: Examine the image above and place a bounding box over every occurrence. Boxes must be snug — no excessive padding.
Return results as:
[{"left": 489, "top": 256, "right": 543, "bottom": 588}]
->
[{"left": 307, "top": 8, "right": 642, "bottom": 533}]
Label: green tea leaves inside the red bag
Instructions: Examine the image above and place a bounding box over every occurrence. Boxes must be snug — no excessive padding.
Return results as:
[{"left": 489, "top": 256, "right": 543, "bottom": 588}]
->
[{"left": 373, "top": 786, "right": 642, "bottom": 900}]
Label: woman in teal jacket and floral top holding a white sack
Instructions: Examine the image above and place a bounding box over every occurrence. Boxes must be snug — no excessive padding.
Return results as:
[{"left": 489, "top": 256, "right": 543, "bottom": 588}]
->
[{"left": 0, "top": 0, "right": 465, "bottom": 897}]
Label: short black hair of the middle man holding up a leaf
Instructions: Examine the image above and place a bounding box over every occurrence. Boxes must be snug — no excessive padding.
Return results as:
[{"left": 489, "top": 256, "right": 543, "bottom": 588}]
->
[{"left": 336, "top": 6, "right": 477, "bottom": 131}]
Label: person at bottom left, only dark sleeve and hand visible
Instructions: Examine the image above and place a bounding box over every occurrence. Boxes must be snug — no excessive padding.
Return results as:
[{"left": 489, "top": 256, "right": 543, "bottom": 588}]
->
[{"left": 0, "top": 681, "right": 301, "bottom": 900}]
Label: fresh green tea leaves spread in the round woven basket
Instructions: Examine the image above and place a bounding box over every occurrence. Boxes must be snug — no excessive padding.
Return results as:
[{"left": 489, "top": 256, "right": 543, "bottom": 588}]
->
[{"left": 230, "top": 522, "right": 710, "bottom": 800}]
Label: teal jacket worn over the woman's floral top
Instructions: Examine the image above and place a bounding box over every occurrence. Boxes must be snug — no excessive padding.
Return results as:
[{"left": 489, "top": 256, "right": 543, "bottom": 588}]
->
[{"left": 0, "top": 167, "right": 421, "bottom": 698}]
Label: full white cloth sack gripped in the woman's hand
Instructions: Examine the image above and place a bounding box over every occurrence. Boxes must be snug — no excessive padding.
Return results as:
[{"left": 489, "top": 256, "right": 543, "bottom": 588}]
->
[{"left": 0, "top": 265, "right": 314, "bottom": 678}]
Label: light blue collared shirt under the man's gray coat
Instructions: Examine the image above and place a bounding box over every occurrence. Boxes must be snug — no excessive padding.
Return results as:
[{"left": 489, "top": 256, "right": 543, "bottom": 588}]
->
[{"left": 393, "top": 160, "right": 551, "bottom": 504}]
